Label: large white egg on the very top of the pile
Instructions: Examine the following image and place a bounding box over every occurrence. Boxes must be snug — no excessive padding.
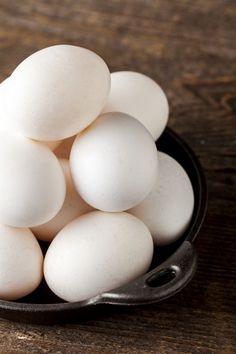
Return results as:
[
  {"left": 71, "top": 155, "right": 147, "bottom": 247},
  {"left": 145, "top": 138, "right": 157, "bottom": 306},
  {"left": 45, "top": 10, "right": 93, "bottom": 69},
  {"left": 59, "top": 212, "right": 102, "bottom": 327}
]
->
[{"left": 5, "top": 45, "right": 110, "bottom": 140}]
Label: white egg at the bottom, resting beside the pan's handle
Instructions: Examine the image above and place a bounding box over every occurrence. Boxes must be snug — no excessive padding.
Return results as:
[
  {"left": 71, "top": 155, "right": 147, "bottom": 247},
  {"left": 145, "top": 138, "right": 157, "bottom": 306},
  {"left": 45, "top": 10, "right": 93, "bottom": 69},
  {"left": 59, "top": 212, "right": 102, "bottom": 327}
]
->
[{"left": 44, "top": 211, "right": 153, "bottom": 302}]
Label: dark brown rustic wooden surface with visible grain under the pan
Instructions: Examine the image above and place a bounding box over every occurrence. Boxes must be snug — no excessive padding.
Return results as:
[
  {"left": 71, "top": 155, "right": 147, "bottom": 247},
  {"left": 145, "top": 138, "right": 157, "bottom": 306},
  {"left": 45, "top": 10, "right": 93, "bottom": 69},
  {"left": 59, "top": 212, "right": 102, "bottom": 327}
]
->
[{"left": 0, "top": 0, "right": 236, "bottom": 354}]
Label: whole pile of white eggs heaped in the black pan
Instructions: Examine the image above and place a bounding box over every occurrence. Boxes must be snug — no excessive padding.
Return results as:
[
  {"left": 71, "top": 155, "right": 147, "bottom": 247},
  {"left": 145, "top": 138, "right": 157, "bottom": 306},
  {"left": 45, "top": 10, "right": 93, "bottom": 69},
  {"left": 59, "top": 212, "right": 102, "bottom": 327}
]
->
[{"left": 0, "top": 45, "right": 194, "bottom": 301}]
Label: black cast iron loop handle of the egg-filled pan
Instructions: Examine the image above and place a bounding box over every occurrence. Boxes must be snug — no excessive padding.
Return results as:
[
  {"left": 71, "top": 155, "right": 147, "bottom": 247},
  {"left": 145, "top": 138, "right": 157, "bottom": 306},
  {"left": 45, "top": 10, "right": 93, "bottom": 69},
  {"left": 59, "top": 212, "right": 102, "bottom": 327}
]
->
[{"left": 98, "top": 241, "right": 197, "bottom": 305}]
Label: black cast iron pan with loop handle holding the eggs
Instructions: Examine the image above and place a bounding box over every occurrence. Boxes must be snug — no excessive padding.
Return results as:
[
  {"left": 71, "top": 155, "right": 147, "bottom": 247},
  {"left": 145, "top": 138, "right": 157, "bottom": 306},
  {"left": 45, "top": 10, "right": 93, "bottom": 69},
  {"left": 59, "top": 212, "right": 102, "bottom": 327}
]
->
[{"left": 0, "top": 128, "right": 207, "bottom": 324}]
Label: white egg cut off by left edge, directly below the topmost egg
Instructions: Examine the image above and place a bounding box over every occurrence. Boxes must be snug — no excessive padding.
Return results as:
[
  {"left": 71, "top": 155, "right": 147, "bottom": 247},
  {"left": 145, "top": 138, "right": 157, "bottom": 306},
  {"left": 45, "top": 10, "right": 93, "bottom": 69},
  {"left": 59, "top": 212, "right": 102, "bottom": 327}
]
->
[{"left": 0, "top": 131, "right": 66, "bottom": 227}]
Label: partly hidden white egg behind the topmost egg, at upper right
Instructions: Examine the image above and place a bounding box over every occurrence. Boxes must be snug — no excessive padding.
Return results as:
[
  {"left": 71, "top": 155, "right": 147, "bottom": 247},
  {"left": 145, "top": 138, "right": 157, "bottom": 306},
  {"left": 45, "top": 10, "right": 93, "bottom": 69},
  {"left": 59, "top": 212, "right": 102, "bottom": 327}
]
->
[{"left": 103, "top": 71, "right": 169, "bottom": 140}]
